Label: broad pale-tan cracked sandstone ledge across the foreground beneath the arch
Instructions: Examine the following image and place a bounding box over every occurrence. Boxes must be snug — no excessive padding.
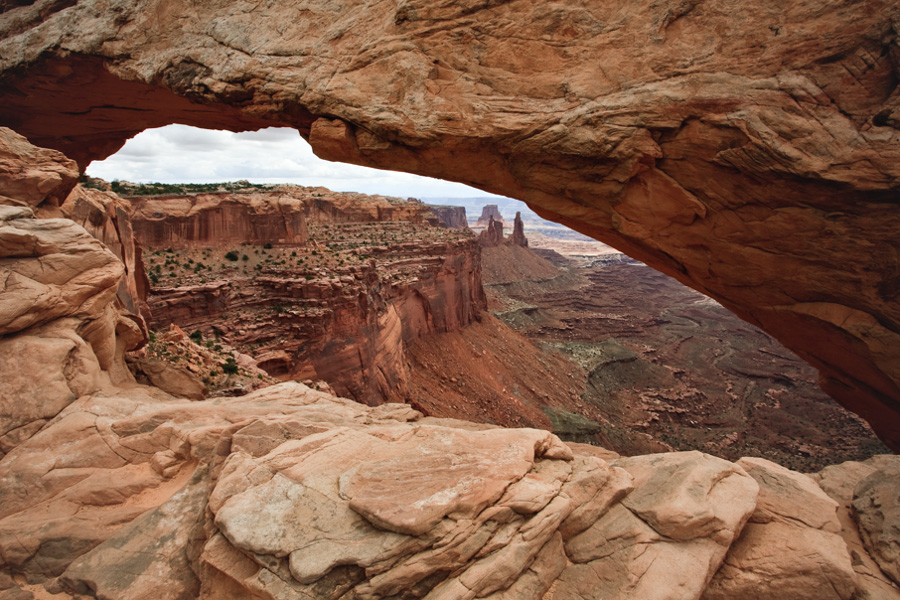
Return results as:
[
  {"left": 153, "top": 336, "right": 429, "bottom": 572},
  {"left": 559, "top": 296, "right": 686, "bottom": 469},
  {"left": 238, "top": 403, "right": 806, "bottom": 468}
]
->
[{"left": 0, "top": 382, "right": 900, "bottom": 600}]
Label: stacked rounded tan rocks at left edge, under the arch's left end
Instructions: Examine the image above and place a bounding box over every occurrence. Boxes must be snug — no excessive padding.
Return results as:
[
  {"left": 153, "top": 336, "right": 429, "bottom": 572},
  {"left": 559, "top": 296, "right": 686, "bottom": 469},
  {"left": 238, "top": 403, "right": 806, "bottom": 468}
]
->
[{"left": 0, "top": 128, "right": 145, "bottom": 456}]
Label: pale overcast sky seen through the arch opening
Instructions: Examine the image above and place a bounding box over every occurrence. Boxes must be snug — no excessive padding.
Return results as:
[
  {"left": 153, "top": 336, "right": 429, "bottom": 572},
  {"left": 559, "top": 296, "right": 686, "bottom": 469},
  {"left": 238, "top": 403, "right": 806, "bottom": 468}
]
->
[{"left": 87, "top": 125, "right": 502, "bottom": 198}]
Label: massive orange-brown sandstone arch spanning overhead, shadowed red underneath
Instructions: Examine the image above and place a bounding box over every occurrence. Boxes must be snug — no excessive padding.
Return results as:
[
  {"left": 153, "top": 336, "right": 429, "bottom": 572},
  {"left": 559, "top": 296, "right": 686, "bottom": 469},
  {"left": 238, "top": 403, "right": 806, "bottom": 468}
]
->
[{"left": 0, "top": 0, "right": 900, "bottom": 448}]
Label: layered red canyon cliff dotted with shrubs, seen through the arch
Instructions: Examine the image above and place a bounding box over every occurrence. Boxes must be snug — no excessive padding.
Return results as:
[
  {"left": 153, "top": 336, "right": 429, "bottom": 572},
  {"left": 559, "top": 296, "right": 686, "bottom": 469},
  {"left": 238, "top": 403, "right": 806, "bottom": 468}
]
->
[{"left": 141, "top": 195, "right": 486, "bottom": 405}]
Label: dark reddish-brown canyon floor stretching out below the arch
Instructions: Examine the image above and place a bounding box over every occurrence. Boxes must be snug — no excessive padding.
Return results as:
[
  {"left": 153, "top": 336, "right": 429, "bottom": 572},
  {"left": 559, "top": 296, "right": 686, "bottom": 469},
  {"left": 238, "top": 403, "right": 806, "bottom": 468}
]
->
[{"left": 483, "top": 240, "right": 888, "bottom": 471}]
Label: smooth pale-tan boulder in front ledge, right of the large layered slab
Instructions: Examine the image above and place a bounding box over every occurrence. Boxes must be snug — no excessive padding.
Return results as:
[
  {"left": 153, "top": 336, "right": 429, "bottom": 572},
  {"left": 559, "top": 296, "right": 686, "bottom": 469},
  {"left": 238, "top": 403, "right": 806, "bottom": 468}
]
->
[{"left": 555, "top": 452, "right": 758, "bottom": 600}]
